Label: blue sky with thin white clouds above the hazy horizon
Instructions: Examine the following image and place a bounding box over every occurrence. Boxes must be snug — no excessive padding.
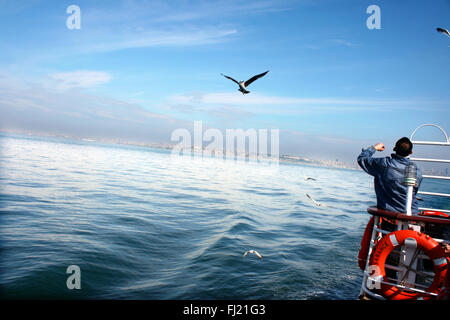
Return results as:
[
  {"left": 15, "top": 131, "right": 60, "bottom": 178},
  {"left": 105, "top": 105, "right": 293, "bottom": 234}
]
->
[{"left": 0, "top": 0, "right": 450, "bottom": 162}]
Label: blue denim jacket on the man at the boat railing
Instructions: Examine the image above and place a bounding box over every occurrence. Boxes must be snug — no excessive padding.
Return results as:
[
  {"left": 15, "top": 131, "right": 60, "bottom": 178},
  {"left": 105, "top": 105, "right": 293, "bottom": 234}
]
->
[{"left": 358, "top": 146, "right": 422, "bottom": 214}]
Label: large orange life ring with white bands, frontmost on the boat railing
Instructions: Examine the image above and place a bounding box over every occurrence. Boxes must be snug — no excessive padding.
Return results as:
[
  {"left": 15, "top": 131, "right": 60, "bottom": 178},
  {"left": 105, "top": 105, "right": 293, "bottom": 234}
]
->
[{"left": 369, "top": 230, "right": 447, "bottom": 300}]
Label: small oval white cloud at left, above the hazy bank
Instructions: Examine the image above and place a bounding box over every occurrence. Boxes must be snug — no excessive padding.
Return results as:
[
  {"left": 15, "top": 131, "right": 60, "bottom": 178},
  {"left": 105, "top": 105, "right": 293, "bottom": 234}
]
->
[{"left": 50, "top": 70, "right": 112, "bottom": 89}]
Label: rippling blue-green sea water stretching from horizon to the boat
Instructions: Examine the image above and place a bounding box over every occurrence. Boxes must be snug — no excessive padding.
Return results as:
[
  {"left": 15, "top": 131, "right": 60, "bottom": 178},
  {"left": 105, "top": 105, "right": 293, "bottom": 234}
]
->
[{"left": 0, "top": 134, "right": 449, "bottom": 300}]
